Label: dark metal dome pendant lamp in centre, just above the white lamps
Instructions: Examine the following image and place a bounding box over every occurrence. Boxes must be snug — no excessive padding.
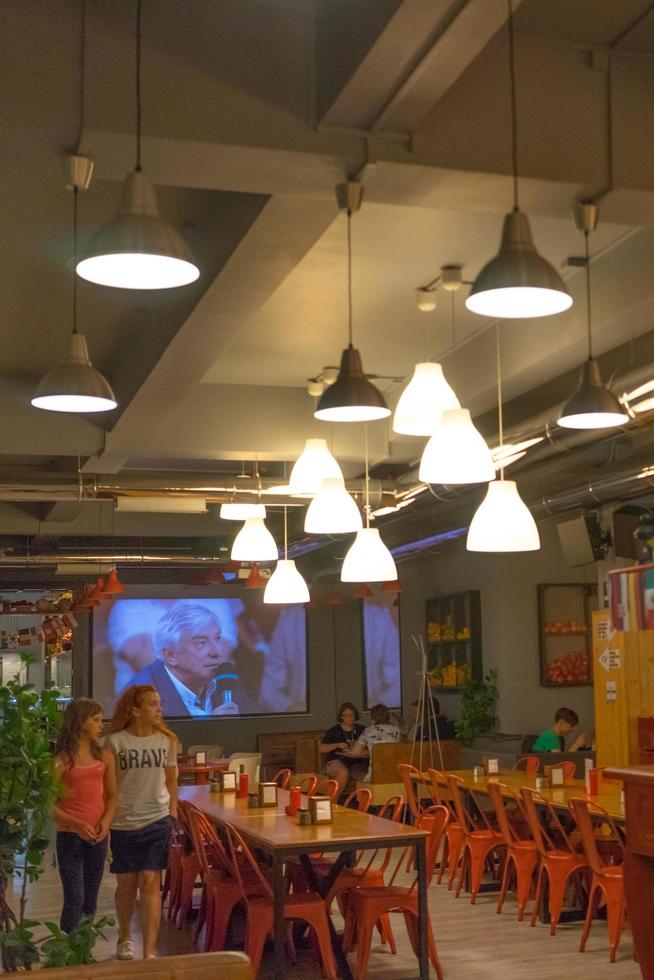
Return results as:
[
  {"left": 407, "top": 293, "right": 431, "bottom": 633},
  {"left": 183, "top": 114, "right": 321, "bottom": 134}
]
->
[{"left": 313, "top": 181, "right": 391, "bottom": 422}]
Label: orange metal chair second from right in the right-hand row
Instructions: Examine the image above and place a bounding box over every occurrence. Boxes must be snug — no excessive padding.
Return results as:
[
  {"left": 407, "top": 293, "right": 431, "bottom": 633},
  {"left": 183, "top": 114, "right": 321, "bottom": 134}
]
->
[{"left": 520, "top": 786, "right": 588, "bottom": 936}]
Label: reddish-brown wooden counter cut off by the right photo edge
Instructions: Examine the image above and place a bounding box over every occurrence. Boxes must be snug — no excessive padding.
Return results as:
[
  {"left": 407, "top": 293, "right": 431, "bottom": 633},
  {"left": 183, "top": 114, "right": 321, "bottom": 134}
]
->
[{"left": 607, "top": 766, "right": 654, "bottom": 980}]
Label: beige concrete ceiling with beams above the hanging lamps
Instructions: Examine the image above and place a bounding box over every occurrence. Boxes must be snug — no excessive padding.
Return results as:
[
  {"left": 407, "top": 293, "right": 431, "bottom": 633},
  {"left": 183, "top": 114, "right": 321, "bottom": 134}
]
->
[{"left": 0, "top": 0, "right": 654, "bottom": 560}]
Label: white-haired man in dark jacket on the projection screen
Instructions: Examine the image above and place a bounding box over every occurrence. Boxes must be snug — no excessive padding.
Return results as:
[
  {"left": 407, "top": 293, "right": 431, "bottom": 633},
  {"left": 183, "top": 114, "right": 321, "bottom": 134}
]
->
[{"left": 130, "top": 602, "right": 252, "bottom": 718}]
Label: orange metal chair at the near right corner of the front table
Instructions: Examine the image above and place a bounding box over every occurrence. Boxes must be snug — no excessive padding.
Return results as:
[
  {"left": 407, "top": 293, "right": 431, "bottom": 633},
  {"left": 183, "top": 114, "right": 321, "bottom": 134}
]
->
[{"left": 343, "top": 806, "right": 448, "bottom": 980}]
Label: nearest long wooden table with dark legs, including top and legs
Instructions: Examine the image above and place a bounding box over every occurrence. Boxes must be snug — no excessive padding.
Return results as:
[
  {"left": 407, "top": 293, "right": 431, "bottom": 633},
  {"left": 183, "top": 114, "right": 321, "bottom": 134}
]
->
[{"left": 179, "top": 786, "right": 429, "bottom": 980}]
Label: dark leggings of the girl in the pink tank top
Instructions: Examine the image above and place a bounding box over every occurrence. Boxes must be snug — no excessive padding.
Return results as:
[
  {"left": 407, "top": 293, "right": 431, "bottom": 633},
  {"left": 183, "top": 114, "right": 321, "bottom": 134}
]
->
[{"left": 57, "top": 831, "right": 108, "bottom": 932}]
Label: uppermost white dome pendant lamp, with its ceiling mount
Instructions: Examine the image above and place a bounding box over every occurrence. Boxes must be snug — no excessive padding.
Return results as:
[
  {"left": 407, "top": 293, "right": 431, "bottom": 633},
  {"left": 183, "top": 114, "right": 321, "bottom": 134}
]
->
[{"left": 393, "top": 266, "right": 462, "bottom": 436}]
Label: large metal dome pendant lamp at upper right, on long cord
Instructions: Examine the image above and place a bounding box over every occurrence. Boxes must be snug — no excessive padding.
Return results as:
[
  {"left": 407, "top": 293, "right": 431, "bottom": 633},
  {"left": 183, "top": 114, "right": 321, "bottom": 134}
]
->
[{"left": 466, "top": 0, "right": 572, "bottom": 319}]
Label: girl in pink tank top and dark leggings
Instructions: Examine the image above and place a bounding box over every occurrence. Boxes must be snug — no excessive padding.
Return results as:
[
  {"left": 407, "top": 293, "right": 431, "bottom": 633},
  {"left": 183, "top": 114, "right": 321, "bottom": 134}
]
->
[{"left": 55, "top": 698, "right": 116, "bottom": 932}]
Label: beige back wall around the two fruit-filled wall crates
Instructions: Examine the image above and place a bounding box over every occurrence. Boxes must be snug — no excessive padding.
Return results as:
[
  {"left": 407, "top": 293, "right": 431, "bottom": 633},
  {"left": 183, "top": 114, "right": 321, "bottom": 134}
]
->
[{"left": 400, "top": 520, "right": 596, "bottom": 733}]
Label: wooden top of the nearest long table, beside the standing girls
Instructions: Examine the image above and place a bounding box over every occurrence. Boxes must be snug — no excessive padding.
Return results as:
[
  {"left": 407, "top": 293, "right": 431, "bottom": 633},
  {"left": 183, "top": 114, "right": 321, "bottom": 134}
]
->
[{"left": 179, "top": 786, "right": 426, "bottom": 853}]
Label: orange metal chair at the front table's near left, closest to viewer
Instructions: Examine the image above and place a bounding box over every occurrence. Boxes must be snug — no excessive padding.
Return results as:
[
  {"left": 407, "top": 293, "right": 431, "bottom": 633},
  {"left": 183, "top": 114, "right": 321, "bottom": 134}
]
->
[{"left": 223, "top": 823, "right": 336, "bottom": 980}]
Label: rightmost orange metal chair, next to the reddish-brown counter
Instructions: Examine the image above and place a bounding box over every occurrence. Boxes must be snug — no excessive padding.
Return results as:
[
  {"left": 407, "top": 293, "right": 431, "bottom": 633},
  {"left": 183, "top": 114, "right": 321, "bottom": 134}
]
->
[{"left": 570, "top": 799, "right": 625, "bottom": 963}]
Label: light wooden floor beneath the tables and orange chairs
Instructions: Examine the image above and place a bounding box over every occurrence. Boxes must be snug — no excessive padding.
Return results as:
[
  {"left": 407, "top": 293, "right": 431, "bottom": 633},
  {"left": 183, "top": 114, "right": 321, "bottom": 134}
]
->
[{"left": 16, "top": 848, "right": 640, "bottom": 980}]
